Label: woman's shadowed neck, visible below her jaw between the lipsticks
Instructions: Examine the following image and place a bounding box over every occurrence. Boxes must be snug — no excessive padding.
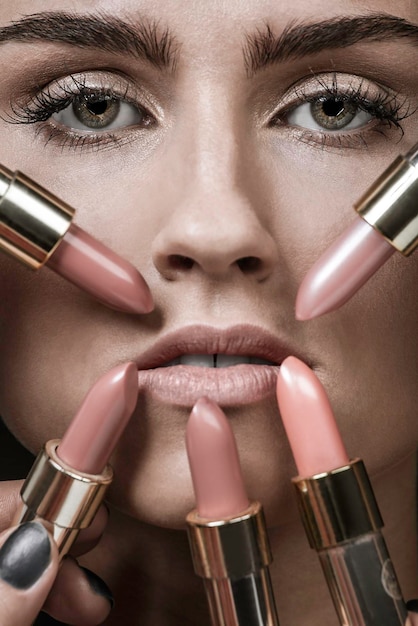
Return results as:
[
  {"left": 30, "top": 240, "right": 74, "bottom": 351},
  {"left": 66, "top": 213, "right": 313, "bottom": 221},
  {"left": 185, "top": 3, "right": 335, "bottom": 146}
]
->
[{"left": 83, "top": 456, "right": 418, "bottom": 626}]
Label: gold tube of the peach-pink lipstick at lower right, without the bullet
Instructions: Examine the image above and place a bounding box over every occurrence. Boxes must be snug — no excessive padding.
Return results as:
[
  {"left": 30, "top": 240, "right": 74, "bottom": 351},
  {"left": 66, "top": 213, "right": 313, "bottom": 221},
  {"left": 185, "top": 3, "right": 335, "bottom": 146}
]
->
[{"left": 293, "top": 459, "right": 407, "bottom": 626}]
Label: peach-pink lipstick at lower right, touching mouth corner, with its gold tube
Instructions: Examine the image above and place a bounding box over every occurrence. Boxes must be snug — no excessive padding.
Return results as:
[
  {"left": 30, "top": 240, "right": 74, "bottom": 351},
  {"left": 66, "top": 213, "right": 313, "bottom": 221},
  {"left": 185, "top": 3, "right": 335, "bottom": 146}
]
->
[{"left": 277, "top": 357, "right": 407, "bottom": 626}]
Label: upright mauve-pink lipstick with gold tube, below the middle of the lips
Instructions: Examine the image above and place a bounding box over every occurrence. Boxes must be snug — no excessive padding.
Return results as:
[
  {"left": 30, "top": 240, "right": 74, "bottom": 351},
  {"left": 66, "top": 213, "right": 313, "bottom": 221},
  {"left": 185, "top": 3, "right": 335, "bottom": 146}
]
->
[{"left": 186, "top": 398, "right": 279, "bottom": 626}]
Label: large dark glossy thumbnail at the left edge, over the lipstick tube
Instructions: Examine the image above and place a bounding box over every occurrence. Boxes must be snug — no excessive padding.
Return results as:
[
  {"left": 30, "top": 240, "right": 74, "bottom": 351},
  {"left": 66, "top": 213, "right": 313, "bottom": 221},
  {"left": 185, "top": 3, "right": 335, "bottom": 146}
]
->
[{"left": 0, "top": 522, "right": 51, "bottom": 589}]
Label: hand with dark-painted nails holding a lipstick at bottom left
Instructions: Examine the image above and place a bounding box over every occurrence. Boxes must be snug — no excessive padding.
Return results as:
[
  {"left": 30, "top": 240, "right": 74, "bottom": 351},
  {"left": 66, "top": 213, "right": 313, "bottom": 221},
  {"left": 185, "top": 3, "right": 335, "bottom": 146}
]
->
[{"left": 0, "top": 481, "right": 112, "bottom": 626}]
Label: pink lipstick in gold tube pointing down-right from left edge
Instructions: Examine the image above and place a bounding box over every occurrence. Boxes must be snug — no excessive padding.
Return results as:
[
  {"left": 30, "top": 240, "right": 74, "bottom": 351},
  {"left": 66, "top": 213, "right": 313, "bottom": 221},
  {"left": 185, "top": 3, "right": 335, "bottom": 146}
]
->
[{"left": 0, "top": 165, "right": 153, "bottom": 313}]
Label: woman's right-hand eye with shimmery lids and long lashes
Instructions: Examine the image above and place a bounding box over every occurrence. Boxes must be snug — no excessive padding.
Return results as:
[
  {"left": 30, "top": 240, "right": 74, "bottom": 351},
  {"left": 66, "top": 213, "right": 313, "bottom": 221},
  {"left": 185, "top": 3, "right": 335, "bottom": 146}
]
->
[{"left": 270, "top": 72, "right": 412, "bottom": 148}]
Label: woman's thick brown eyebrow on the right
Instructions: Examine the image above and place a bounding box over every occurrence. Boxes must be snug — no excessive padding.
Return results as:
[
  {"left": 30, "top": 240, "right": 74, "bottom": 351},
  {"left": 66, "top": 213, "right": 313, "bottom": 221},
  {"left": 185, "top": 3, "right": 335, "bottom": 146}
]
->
[{"left": 243, "top": 13, "right": 418, "bottom": 76}]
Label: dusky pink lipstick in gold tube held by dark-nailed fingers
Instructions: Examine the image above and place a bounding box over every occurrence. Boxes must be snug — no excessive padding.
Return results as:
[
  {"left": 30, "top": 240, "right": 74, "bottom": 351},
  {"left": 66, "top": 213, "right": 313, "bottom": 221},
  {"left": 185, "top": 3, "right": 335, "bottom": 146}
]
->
[{"left": 13, "top": 363, "right": 138, "bottom": 559}]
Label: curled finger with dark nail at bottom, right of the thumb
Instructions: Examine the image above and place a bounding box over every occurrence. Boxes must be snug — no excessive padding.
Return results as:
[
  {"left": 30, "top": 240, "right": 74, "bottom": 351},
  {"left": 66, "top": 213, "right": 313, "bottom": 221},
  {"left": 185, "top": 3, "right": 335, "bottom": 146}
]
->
[{"left": 42, "top": 557, "right": 113, "bottom": 626}]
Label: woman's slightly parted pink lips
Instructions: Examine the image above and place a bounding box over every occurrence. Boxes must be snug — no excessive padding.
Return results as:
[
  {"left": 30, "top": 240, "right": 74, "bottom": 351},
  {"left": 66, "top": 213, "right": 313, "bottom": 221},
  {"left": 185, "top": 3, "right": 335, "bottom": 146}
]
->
[{"left": 137, "top": 325, "right": 296, "bottom": 407}]
